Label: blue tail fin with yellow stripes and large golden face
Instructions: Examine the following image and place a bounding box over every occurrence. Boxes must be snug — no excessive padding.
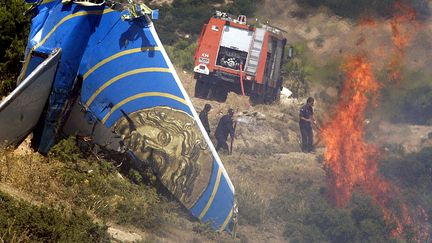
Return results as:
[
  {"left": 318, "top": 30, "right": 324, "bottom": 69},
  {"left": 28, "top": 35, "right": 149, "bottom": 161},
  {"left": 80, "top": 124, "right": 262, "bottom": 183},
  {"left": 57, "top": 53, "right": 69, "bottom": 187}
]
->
[{"left": 75, "top": 9, "right": 237, "bottom": 231}]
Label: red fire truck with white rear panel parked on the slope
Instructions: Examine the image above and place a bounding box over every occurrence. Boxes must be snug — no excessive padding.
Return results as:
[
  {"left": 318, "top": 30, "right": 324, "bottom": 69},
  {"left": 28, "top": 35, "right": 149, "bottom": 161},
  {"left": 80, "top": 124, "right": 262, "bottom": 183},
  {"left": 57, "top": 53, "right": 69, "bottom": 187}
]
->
[{"left": 194, "top": 11, "right": 286, "bottom": 104}]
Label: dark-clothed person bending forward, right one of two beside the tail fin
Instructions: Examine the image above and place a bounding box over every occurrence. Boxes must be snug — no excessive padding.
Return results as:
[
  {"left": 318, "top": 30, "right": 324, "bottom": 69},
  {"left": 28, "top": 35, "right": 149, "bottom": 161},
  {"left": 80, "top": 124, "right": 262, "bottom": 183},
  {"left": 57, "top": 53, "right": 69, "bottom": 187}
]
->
[{"left": 215, "top": 109, "right": 234, "bottom": 151}]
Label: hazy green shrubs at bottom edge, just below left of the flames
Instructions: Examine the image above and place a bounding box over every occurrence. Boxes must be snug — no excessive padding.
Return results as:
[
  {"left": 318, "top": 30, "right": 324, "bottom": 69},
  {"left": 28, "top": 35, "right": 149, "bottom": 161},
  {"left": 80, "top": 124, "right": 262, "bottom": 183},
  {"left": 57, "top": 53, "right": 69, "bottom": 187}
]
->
[{"left": 269, "top": 179, "right": 402, "bottom": 243}]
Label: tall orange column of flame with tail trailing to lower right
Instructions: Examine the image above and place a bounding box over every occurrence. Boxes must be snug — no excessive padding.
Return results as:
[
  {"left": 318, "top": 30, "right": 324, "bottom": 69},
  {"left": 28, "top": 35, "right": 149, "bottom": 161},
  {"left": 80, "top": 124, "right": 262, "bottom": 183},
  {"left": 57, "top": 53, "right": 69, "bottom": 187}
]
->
[{"left": 322, "top": 55, "right": 412, "bottom": 236}]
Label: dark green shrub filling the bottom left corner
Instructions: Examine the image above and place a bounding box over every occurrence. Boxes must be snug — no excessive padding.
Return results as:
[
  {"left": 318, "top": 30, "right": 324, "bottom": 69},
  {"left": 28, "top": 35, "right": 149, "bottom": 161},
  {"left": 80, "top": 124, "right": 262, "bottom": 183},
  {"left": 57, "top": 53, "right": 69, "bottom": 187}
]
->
[{"left": 0, "top": 192, "right": 110, "bottom": 242}]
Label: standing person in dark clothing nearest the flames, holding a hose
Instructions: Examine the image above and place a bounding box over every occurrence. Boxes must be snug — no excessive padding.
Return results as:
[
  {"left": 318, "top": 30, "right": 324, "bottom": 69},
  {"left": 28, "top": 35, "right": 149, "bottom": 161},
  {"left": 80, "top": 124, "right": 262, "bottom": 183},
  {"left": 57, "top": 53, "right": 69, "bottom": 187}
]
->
[{"left": 299, "top": 97, "right": 315, "bottom": 152}]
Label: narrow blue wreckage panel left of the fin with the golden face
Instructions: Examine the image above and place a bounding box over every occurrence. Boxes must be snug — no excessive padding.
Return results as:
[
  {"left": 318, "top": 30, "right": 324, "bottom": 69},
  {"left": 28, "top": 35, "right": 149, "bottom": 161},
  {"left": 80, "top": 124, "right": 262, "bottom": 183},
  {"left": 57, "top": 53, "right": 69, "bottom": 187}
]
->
[{"left": 23, "top": 0, "right": 113, "bottom": 153}]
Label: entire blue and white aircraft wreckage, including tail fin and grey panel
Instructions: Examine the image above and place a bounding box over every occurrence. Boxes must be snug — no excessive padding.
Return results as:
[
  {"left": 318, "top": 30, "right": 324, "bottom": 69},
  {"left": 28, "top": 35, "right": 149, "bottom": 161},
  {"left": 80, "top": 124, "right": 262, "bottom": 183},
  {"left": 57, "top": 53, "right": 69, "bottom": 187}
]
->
[{"left": 0, "top": 0, "right": 237, "bottom": 231}]
